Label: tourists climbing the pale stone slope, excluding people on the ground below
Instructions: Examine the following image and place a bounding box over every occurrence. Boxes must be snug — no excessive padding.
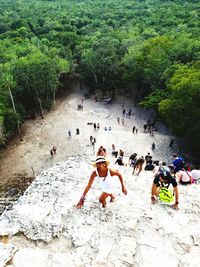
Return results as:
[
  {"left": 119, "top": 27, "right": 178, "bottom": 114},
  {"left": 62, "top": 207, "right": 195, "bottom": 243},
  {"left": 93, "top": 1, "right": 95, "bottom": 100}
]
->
[{"left": 77, "top": 144, "right": 200, "bottom": 209}]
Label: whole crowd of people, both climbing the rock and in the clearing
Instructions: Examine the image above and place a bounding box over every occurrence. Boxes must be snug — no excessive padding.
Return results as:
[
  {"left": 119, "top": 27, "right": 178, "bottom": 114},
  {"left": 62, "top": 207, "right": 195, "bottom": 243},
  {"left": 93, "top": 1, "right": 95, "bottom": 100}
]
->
[{"left": 54, "top": 96, "right": 200, "bottom": 209}]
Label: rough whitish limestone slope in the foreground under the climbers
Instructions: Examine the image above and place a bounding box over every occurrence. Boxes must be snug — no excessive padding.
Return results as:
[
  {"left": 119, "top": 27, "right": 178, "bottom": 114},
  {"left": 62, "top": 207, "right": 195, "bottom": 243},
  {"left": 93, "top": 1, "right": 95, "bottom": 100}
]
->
[{"left": 0, "top": 156, "right": 200, "bottom": 267}]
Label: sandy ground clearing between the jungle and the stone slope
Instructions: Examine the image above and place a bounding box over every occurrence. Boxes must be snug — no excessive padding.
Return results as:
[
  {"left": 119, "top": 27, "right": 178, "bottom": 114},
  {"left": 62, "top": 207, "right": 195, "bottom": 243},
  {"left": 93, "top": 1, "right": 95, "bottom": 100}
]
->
[{"left": 0, "top": 81, "right": 177, "bottom": 211}]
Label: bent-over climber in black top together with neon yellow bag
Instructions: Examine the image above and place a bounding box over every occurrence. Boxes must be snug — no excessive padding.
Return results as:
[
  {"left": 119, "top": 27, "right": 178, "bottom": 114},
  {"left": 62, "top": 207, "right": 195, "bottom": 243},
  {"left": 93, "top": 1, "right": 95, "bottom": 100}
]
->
[{"left": 151, "top": 167, "right": 179, "bottom": 209}]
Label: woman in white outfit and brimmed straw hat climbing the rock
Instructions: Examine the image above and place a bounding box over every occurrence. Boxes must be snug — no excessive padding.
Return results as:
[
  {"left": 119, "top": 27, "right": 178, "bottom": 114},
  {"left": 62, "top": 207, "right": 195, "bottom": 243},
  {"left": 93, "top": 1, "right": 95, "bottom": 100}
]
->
[{"left": 76, "top": 156, "right": 127, "bottom": 208}]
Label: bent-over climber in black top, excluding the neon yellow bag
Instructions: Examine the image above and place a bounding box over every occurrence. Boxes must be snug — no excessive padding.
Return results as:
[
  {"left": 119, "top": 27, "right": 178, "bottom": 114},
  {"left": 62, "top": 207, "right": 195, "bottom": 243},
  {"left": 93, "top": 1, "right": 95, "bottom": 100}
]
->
[{"left": 151, "top": 167, "right": 179, "bottom": 209}]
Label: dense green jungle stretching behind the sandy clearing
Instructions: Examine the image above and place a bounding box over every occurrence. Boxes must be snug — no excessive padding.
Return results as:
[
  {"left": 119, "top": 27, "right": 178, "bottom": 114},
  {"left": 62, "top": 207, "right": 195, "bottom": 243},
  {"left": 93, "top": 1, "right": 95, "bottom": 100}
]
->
[{"left": 0, "top": 0, "right": 200, "bottom": 159}]
